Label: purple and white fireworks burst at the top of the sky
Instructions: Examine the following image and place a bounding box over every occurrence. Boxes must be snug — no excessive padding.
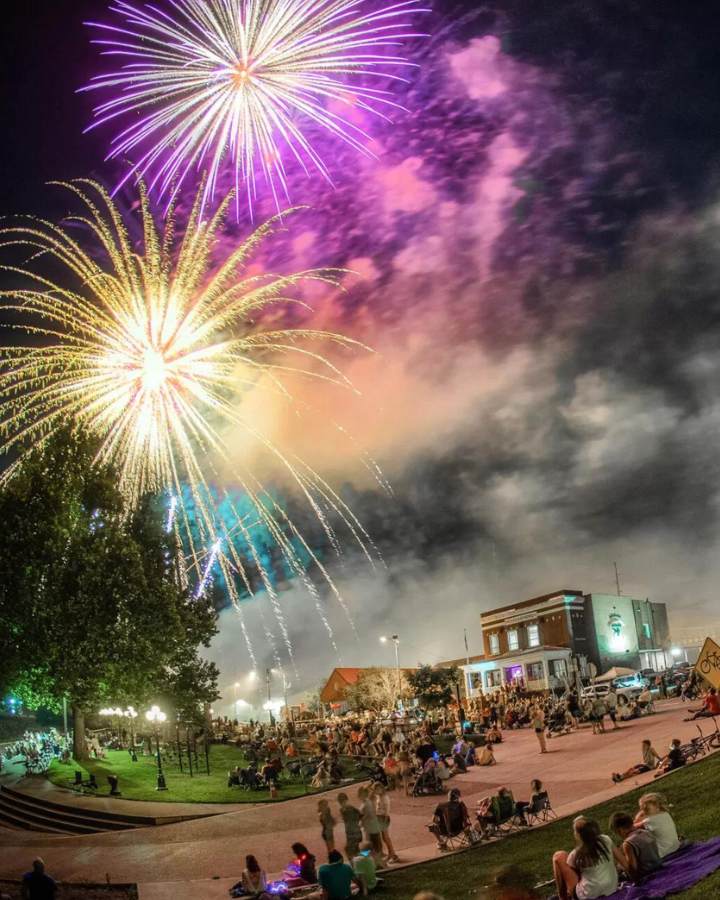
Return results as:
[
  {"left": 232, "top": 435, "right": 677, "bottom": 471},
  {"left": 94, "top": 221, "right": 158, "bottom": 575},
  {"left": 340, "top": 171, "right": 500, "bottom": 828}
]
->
[{"left": 84, "top": 0, "right": 419, "bottom": 209}]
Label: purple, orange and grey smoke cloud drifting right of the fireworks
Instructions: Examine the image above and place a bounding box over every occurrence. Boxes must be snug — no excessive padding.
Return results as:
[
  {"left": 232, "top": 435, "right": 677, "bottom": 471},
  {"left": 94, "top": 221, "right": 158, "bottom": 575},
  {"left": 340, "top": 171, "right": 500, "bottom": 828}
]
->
[{"left": 198, "top": 4, "right": 720, "bottom": 693}]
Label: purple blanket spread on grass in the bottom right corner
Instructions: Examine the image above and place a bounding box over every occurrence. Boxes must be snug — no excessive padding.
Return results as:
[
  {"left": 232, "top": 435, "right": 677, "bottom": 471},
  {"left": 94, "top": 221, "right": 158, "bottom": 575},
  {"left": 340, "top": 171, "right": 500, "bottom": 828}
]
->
[{"left": 548, "top": 836, "right": 720, "bottom": 900}]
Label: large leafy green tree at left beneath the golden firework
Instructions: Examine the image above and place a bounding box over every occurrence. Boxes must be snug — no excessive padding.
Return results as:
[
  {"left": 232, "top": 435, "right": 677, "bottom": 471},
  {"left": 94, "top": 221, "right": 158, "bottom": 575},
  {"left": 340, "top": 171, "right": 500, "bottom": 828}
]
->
[{"left": 0, "top": 428, "right": 218, "bottom": 758}]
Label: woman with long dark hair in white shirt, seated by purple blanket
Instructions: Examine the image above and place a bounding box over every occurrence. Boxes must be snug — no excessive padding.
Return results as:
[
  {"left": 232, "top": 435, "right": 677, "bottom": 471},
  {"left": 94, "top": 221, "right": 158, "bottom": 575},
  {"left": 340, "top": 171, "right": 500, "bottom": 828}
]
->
[{"left": 553, "top": 818, "right": 625, "bottom": 900}]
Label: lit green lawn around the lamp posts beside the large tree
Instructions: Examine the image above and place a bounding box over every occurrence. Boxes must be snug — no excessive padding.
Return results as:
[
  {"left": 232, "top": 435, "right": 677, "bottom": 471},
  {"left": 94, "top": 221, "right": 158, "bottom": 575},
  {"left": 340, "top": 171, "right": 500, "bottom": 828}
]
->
[{"left": 47, "top": 744, "right": 361, "bottom": 803}]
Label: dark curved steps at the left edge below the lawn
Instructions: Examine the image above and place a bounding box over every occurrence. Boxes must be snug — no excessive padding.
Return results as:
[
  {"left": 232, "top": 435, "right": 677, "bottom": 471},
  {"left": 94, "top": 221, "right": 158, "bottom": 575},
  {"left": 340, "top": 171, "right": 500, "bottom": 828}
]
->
[{"left": 0, "top": 785, "right": 152, "bottom": 835}]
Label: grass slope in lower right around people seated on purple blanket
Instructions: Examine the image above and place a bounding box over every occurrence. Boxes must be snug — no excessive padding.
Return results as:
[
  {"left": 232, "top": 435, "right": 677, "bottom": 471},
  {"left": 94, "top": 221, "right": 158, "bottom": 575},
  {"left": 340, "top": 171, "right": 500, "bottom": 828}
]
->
[{"left": 383, "top": 753, "right": 720, "bottom": 900}]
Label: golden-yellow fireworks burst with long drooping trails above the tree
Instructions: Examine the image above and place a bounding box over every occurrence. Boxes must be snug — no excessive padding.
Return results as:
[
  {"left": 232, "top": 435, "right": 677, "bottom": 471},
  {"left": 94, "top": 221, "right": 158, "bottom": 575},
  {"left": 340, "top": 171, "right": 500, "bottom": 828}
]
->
[{"left": 0, "top": 181, "right": 382, "bottom": 664}]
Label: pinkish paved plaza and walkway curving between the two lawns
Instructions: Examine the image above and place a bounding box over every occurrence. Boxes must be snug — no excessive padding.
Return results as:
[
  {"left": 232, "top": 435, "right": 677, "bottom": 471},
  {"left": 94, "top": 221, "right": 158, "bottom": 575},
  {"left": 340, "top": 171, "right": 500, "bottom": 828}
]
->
[{"left": 0, "top": 700, "right": 710, "bottom": 900}]
